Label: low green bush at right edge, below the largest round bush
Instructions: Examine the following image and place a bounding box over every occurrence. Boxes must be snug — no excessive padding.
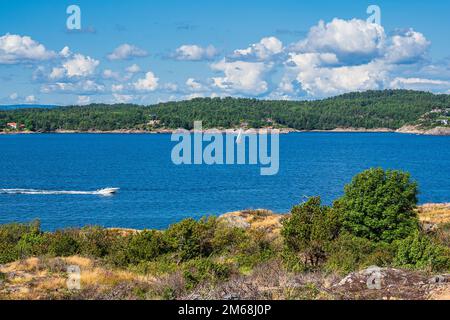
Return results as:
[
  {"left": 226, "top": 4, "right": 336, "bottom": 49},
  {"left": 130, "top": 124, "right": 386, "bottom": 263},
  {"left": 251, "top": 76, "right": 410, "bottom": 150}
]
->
[{"left": 395, "top": 231, "right": 450, "bottom": 271}]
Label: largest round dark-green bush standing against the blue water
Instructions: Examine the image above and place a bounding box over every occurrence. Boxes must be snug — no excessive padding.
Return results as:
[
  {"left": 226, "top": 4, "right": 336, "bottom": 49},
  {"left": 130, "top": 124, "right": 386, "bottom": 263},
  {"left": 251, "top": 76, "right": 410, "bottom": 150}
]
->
[{"left": 334, "top": 168, "right": 419, "bottom": 242}]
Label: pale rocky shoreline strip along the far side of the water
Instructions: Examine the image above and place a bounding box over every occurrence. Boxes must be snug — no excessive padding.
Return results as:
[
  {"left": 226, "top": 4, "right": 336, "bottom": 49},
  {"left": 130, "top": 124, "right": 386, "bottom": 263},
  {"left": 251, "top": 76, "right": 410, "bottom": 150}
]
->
[{"left": 0, "top": 126, "right": 450, "bottom": 136}]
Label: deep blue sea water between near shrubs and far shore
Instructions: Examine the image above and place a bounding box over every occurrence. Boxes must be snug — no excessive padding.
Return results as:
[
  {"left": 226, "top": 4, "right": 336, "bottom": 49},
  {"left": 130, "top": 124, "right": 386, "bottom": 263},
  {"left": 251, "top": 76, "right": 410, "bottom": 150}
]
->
[{"left": 0, "top": 133, "right": 450, "bottom": 230}]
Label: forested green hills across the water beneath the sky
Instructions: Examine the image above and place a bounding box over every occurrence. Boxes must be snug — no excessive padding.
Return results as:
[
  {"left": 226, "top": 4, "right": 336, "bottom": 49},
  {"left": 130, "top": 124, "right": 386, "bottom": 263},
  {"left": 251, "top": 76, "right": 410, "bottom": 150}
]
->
[{"left": 0, "top": 90, "right": 450, "bottom": 132}]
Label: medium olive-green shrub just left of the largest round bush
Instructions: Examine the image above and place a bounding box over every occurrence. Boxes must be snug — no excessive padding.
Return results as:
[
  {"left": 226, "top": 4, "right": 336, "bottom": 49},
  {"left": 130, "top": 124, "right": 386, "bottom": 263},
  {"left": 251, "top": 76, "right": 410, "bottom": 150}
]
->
[{"left": 281, "top": 197, "right": 340, "bottom": 266}]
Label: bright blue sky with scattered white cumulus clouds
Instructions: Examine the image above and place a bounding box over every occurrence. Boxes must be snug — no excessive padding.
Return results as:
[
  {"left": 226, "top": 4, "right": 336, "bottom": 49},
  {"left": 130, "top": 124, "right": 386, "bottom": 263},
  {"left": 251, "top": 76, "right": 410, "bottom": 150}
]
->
[{"left": 0, "top": 0, "right": 450, "bottom": 105}]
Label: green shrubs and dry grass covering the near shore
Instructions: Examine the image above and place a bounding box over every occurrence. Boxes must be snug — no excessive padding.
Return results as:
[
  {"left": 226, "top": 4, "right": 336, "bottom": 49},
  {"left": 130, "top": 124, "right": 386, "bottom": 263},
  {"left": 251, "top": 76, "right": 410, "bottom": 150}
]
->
[{"left": 0, "top": 169, "right": 450, "bottom": 299}]
